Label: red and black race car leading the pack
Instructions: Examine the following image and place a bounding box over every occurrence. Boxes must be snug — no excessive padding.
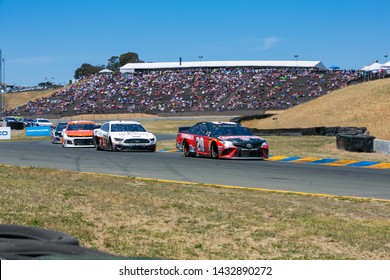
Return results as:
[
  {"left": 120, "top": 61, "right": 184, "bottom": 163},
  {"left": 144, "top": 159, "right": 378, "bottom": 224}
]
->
[{"left": 176, "top": 122, "right": 269, "bottom": 159}]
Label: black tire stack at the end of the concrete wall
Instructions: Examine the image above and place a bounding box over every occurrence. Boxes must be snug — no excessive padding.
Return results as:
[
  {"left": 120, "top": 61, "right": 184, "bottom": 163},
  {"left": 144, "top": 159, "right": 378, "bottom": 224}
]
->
[{"left": 336, "top": 134, "right": 375, "bottom": 153}]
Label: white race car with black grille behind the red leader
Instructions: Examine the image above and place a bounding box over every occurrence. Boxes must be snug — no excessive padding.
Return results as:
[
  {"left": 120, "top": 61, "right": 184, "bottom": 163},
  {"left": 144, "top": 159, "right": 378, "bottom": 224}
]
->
[{"left": 94, "top": 121, "right": 157, "bottom": 152}]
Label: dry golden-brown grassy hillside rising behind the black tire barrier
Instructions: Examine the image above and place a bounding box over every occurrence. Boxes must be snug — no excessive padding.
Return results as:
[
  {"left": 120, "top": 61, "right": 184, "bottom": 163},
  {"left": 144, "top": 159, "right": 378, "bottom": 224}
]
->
[{"left": 243, "top": 79, "right": 390, "bottom": 140}]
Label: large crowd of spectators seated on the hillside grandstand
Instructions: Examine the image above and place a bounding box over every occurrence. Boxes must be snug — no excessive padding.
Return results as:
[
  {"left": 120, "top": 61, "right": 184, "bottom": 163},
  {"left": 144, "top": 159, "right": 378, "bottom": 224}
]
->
[{"left": 2, "top": 68, "right": 360, "bottom": 116}]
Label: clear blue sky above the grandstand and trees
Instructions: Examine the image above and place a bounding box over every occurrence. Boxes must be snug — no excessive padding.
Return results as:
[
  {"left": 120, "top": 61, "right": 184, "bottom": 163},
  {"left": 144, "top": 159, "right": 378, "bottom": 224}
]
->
[{"left": 0, "top": 0, "right": 390, "bottom": 85}]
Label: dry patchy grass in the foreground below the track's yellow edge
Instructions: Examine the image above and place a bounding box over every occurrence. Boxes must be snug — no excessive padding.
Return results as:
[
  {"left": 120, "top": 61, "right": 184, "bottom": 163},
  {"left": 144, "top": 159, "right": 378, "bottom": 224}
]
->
[{"left": 0, "top": 165, "right": 390, "bottom": 259}]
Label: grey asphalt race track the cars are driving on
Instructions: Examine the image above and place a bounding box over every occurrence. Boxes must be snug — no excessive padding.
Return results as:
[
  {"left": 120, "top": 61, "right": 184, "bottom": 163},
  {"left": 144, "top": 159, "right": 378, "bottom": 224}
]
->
[{"left": 0, "top": 135, "right": 390, "bottom": 200}]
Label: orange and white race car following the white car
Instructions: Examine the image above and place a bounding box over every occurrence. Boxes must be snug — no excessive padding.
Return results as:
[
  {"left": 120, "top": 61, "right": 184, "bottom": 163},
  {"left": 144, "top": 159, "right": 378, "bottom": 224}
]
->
[{"left": 61, "top": 121, "right": 96, "bottom": 148}]
